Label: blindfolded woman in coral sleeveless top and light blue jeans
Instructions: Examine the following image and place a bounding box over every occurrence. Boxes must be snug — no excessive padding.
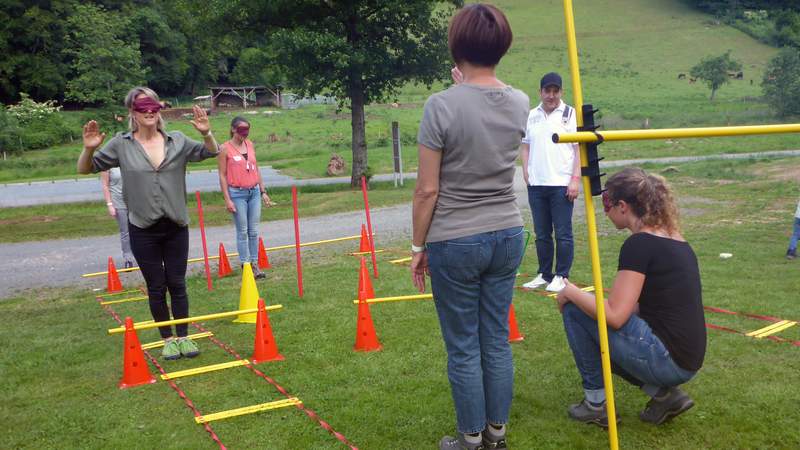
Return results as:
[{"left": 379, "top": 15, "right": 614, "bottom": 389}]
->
[{"left": 217, "top": 116, "right": 274, "bottom": 278}]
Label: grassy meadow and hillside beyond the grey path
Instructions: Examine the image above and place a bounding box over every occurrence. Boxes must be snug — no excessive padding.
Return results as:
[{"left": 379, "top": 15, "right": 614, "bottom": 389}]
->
[{"left": 0, "top": 0, "right": 800, "bottom": 182}]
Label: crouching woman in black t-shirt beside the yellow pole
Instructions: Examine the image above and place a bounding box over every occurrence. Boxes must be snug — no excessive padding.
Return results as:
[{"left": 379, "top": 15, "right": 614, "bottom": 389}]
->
[{"left": 557, "top": 168, "right": 706, "bottom": 427}]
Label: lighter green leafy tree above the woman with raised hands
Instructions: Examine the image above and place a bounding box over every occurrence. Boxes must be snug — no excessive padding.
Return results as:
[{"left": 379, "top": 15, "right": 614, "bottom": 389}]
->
[{"left": 65, "top": 4, "right": 147, "bottom": 104}]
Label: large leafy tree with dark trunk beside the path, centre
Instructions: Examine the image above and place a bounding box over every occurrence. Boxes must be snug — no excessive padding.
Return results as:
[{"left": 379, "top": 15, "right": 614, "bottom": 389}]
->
[{"left": 221, "top": 0, "right": 462, "bottom": 186}]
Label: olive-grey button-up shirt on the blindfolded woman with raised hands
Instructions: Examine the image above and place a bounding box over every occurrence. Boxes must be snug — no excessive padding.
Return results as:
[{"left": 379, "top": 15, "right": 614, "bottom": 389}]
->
[{"left": 92, "top": 131, "right": 217, "bottom": 228}]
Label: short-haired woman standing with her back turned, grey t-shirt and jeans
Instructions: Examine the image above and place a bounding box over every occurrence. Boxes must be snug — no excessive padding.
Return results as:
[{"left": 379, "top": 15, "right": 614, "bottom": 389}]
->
[{"left": 411, "top": 4, "right": 529, "bottom": 450}]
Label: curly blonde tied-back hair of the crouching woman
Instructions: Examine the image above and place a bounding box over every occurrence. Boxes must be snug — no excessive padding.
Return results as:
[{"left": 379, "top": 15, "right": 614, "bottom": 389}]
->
[{"left": 606, "top": 167, "right": 680, "bottom": 234}]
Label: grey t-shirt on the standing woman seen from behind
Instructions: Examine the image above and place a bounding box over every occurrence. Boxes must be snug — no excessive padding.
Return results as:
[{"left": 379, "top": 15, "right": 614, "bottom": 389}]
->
[{"left": 417, "top": 84, "right": 530, "bottom": 242}]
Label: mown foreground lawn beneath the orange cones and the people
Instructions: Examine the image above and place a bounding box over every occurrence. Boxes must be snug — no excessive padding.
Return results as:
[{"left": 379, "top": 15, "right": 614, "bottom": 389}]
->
[{"left": 0, "top": 159, "right": 800, "bottom": 449}]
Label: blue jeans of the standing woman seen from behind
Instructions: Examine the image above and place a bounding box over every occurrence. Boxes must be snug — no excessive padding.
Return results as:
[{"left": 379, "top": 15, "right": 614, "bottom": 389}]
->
[{"left": 427, "top": 227, "right": 524, "bottom": 433}]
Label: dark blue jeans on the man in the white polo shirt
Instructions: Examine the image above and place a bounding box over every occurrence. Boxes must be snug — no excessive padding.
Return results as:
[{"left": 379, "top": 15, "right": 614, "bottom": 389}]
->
[{"left": 528, "top": 186, "right": 575, "bottom": 281}]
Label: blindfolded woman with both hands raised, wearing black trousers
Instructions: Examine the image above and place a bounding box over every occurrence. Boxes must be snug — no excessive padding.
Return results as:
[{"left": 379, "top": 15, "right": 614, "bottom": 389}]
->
[{"left": 78, "top": 87, "right": 219, "bottom": 359}]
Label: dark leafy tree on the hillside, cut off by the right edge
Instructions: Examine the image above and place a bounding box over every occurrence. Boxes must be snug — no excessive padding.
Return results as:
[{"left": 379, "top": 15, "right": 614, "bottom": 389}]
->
[{"left": 761, "top": 47, "right": 800, "bottom": 116}]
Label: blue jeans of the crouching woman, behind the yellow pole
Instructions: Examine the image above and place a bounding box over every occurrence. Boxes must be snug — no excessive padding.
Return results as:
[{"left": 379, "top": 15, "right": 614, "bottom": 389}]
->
[{"left": 563, "top": 303, "right": 697, "bottom": 403}]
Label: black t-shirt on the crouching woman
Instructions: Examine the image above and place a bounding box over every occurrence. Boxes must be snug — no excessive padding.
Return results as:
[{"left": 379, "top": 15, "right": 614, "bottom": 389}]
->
[{"left": 618, "top": 233, "right": 706, "bottom": 371}]
